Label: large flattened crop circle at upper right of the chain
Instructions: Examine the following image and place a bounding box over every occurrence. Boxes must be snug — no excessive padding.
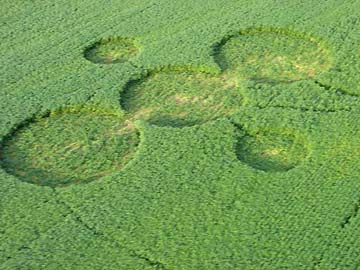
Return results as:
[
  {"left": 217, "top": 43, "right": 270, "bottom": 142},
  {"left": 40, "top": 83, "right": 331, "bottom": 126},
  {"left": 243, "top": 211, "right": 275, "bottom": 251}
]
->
[{"left": 216, "top": 29, "right": 331, "bottom": 82}]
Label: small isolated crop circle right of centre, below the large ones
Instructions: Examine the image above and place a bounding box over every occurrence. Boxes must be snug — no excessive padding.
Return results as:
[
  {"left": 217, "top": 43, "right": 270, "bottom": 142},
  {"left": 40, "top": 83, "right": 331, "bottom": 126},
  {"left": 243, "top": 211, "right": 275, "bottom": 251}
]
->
[{"left": 236, "top": 132, "right": 307, "bottom": 172}]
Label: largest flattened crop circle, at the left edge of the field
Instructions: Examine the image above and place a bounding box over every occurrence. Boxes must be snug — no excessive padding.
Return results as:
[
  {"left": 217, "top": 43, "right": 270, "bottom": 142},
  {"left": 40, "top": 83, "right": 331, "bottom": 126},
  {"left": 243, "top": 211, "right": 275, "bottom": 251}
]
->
[{"left": 0, "top": 110, "right": 139, "bottom": 187}]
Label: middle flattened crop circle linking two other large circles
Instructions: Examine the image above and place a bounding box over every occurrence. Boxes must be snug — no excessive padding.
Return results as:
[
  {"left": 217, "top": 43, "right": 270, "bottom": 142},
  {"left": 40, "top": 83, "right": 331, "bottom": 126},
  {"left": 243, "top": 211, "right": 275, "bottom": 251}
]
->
[{"left": 121, "top": 70, "right": 243, "bottom": 127}]
